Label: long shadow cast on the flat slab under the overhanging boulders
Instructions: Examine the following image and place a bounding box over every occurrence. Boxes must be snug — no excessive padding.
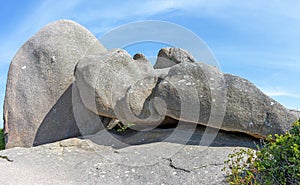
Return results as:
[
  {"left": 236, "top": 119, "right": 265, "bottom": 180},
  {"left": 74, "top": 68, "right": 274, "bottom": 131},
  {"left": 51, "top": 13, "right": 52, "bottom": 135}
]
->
[{"left": 84, "top": 122, "right": 260, "bottom": 149}]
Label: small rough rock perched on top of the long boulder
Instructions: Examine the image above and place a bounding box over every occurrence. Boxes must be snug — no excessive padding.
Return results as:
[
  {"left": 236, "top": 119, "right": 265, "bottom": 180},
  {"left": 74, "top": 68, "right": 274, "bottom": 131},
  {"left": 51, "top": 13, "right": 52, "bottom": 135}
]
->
[{"left": 154, "top": 48, "right": 196, "bottom": 69}]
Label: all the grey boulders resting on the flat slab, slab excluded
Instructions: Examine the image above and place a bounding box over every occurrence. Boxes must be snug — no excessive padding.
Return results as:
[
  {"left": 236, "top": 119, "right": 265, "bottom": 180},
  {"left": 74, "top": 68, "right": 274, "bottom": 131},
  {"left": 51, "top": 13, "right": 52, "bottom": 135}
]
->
[{"left": 4, "top": 21, "right": 297, "bottom": 148}]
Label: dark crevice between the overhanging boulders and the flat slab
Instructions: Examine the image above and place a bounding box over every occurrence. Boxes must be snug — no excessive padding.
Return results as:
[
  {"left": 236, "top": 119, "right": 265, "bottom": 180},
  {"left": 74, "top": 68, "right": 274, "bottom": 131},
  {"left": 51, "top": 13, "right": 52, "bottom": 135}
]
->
[{"left": 95, "top": 120, "right": 261, "bottom": 149}]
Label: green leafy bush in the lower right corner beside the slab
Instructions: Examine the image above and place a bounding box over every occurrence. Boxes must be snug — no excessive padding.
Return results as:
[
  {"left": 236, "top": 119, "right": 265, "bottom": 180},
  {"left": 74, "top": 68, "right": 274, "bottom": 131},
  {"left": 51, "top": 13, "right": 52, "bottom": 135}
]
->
[{"left": 222, "top": 120, "right": 300, "bottom": 185}]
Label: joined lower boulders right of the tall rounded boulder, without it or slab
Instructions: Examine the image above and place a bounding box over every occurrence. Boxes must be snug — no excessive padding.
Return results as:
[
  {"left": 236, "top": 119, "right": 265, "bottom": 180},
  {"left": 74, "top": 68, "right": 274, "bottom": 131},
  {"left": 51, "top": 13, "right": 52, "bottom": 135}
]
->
[{"left": 75, "top": 48, "right": 297, "bottom": 138}]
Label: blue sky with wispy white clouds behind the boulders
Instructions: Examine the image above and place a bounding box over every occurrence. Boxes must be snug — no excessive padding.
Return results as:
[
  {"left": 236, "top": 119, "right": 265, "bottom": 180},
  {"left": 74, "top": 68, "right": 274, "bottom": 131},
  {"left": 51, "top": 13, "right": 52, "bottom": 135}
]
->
[{"left": 0, "top": 0, "right": 300, "bottom": 127}]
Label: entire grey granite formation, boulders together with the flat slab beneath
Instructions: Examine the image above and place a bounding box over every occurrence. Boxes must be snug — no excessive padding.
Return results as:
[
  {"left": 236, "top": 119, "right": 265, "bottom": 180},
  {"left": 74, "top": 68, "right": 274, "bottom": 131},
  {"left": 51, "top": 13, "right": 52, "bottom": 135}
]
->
[{"left": 0, "top": 20, "right": 299, "bottom": 185}]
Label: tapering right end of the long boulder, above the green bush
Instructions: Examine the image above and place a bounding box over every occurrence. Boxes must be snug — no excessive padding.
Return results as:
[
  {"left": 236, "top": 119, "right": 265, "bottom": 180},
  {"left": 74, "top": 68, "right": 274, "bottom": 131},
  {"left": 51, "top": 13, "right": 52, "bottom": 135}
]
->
[{"left": 222, "top": 74, "right": 297, "bottom": 137}]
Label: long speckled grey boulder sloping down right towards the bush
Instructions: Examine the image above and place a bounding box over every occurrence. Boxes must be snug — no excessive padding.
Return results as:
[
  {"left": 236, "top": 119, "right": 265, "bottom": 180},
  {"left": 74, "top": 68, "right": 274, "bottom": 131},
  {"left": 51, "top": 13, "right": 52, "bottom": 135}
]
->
[{"left": 152, "top": 63, "right": 297, "bottom": 138}]
